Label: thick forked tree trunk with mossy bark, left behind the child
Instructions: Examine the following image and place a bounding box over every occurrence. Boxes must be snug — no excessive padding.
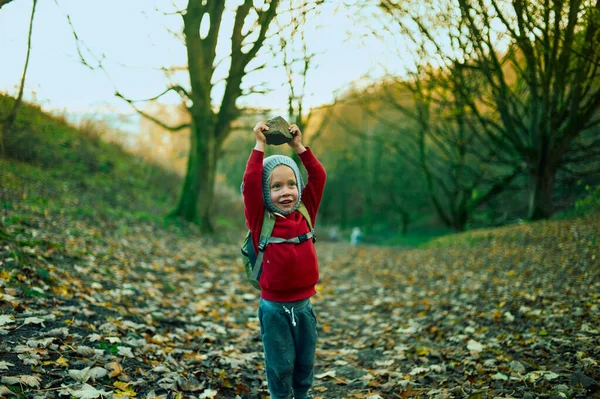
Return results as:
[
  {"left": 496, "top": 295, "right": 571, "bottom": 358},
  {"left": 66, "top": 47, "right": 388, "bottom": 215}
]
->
[{"left": 118, "top": 0, "right": 279, "bottom": 232}]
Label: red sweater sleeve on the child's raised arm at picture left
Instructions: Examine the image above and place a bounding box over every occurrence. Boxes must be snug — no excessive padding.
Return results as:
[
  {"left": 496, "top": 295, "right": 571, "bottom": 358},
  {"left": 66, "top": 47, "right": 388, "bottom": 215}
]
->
[{"left": 242, "top": 149, "right": 265, "bottom": 232}]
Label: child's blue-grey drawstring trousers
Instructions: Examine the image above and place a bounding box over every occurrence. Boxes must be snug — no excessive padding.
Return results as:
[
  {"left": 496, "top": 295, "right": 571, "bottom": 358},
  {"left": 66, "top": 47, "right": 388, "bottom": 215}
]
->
[{"left": 258, "top": 298, "right": 317, "bottom": 399}]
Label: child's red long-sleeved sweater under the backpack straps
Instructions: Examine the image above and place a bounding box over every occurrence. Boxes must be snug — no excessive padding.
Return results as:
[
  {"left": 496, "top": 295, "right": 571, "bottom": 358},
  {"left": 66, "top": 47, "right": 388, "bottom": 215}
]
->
[{"left": 243, "top": 149, "right": 327, "bottom": 302}]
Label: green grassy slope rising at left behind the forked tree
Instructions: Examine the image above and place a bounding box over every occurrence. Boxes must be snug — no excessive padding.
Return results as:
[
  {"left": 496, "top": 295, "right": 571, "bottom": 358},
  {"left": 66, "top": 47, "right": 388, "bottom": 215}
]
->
[{"left": 0, "top": 95, "right": 248, "bottom": 239}]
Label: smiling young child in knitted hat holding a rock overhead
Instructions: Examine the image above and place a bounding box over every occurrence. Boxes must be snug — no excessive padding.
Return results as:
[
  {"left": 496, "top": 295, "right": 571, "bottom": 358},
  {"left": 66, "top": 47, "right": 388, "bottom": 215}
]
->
[{"left": 242, "top": 122, "right": 326, "bottom": 399}]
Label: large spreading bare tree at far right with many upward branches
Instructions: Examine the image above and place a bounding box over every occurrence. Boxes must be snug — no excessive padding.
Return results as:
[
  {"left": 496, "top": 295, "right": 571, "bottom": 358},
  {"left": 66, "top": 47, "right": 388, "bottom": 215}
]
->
[{"left": 381, "top": 0, "right": 600, "bottom": 219}]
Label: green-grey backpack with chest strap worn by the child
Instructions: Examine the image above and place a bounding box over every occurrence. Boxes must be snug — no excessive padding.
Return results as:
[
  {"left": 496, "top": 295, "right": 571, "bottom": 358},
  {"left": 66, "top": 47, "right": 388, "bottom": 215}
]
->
[{"left": 241, "top": 202, "right": 315, "bottom": 290}]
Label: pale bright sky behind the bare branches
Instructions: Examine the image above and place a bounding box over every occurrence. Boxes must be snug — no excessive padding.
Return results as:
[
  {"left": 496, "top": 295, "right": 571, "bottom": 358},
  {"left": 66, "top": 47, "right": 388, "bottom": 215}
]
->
[{"left": 0, "top": 0, "right": 406, "bottom": 124}]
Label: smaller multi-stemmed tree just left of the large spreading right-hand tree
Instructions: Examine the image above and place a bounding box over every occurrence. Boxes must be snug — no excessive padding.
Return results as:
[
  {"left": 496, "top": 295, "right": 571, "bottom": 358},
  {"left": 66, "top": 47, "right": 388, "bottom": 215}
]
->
[{"left": 385, "top": 68, "right": 520, "bottom": 231}]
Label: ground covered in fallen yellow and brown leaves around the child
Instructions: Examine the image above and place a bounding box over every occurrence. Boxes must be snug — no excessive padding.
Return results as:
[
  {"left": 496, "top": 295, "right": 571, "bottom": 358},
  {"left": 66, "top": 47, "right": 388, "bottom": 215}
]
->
[{"left": 0, "top": 214, "right": 600, "bottom": 399}]
